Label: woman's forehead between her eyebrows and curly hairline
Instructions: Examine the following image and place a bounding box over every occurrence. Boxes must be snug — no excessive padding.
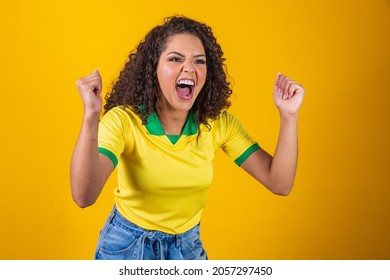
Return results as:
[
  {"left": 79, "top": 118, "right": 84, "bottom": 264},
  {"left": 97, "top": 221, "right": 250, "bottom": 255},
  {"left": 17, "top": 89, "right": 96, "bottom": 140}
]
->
[{"left": 163, "top": 33, "right": 205, "bottom": 54}]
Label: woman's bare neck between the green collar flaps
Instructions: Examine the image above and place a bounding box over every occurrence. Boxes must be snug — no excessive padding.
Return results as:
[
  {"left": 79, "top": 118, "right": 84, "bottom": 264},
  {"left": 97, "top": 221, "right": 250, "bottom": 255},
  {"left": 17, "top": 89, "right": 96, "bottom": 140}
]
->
[{"left": 157, "top": 108, "right": 189, "bottom": 135}]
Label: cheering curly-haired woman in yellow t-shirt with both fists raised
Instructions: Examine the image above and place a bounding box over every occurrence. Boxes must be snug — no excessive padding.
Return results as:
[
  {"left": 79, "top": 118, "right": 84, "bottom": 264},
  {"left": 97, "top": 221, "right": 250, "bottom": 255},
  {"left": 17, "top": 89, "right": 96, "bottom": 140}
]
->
[{"left": 71, "top": 16, "right": 304, "bottom": 259}]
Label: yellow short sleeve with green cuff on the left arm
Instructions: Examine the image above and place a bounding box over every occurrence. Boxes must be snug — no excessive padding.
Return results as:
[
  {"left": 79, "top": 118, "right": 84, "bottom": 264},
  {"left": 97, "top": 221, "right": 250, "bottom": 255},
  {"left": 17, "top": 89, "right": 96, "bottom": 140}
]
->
[{"left": 98, "top": 108, "right": 126, "bottom": 167}]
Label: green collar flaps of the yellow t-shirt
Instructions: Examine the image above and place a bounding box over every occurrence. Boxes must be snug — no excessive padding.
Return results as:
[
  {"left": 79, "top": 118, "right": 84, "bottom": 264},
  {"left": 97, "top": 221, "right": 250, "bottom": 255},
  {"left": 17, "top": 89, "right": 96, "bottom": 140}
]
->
[{"left": 145, "top": 110, "right": 198, "bottom": 137}]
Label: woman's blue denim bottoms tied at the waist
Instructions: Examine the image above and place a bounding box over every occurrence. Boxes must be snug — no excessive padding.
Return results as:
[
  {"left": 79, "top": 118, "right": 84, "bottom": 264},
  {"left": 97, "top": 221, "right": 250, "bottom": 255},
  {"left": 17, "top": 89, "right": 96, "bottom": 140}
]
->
[{"left": 95, "top": 207, "right": 207, "bottom": 260}]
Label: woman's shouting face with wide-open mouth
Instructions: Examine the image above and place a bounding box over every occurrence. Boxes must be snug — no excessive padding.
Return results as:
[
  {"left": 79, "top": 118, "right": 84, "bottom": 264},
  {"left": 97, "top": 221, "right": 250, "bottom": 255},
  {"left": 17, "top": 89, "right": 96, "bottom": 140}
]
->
[{"left": 157, "top": 33, "right": 207, "bottom": 114}]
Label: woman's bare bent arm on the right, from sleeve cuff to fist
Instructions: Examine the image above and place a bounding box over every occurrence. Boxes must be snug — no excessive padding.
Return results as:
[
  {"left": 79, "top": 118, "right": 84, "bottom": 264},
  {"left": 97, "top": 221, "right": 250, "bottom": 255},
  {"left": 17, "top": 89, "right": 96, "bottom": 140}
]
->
[{"left": 241, "top": 73, "right": 305, "bottom": 195}]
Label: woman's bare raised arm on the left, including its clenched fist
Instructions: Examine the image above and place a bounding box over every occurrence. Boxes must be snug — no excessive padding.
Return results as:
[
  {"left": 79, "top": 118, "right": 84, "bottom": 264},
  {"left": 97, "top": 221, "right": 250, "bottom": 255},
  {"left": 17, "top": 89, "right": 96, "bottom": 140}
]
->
[{"left": 70, "top": 70, "right": 114, "bottom": 208}]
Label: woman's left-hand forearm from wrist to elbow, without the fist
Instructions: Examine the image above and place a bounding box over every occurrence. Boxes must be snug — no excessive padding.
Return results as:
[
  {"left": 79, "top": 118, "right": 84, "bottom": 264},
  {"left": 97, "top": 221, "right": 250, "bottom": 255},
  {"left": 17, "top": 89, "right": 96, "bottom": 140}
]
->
[{"left": 70, "top": 114, "right": 102, "bottom": 207}]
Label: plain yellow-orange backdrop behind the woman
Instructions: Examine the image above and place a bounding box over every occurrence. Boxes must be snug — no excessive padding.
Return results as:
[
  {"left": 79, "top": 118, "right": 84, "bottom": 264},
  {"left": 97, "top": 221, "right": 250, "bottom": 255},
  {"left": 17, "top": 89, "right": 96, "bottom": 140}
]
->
[{"left": 0, "top": 0, "right": 390, "bottom": 259}]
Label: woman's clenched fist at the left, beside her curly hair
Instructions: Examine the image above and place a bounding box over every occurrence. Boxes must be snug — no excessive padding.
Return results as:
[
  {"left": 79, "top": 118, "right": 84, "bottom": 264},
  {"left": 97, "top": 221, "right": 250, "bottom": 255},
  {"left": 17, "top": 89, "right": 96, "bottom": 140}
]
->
[{"left": 76, "top": 69, "right": 103, "bottom": 114}]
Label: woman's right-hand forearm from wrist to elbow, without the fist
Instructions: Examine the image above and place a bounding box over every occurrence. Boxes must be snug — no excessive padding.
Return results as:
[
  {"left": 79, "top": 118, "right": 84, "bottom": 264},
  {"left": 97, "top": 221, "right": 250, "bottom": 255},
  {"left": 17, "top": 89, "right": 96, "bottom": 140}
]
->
[{"left": 270, "top": 113, "right": 298, "bottom": 195}]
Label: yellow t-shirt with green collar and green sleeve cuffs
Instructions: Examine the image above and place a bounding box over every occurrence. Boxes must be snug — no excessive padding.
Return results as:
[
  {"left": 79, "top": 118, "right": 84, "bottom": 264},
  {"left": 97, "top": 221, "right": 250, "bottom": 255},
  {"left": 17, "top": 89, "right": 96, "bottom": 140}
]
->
[{"left": 99, "top": 107, "right": 260, "bottom": 234}]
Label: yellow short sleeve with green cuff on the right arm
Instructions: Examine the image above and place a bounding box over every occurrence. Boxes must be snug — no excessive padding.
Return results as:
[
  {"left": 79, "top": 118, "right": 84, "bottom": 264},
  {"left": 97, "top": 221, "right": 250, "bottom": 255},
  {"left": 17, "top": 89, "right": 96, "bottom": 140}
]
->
[{"left": 222, "top": 112, "right": 260, "bottom": 166}]
